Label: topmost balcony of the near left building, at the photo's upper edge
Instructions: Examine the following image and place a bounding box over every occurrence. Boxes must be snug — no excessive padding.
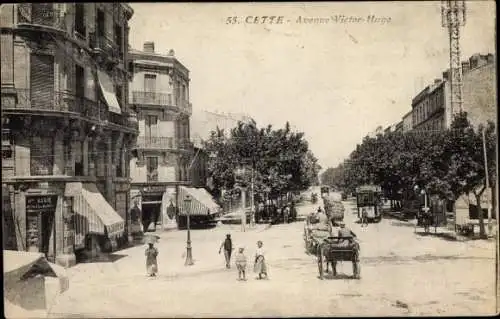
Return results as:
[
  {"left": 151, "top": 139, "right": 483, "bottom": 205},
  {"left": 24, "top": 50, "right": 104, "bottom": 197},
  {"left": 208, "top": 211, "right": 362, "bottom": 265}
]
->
[{"left": 17, "top": 3, "right": 66, "bottom": 32}]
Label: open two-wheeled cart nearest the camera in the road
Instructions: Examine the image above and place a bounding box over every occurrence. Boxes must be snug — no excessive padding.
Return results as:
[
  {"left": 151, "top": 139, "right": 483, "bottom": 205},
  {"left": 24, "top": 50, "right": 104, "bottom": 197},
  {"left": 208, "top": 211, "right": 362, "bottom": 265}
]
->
[{"left": 316, "top": 237, "right": 361, "bottom": 279}]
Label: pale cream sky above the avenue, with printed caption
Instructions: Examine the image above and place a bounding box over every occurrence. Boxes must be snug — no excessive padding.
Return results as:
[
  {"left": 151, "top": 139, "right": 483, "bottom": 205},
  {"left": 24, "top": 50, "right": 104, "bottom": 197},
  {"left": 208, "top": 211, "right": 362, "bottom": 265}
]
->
[{"left": 129, "top": 1, "right": 496, "bottom": 169}]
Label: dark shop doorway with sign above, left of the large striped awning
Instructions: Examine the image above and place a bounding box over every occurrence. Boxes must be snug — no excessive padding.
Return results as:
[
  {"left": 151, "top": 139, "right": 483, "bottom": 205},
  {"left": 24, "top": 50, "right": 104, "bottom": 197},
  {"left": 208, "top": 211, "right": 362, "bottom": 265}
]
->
[{"left": 26, "top": 195, "right": 57, "bottom": 261}]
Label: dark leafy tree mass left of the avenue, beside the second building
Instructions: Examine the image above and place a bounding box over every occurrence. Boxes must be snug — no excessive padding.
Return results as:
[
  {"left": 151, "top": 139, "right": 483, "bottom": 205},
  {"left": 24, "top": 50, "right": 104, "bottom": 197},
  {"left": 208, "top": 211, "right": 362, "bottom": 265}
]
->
[{"left": 205, "top": 120, "right": 320, "bottom": 205}]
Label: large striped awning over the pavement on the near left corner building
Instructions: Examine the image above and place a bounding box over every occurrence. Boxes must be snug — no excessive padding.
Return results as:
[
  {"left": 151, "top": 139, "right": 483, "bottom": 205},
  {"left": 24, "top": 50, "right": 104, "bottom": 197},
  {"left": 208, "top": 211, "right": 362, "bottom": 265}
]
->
[{"left": 65, "top": 183, "right": 125, "bottom": 243}]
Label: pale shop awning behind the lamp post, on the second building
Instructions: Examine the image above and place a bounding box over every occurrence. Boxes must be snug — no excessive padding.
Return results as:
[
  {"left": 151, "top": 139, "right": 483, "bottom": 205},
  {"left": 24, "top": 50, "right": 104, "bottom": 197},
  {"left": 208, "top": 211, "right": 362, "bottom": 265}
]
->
[{"left": 179, "top": 186, "right": 220, "bottom": 215}]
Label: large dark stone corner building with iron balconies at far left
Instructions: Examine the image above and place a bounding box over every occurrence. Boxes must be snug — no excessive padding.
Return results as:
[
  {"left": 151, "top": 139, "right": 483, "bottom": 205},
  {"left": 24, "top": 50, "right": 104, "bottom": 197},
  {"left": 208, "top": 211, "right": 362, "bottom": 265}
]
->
[{"left": 0, "top": 3, "right": 138, "bottom": 266}]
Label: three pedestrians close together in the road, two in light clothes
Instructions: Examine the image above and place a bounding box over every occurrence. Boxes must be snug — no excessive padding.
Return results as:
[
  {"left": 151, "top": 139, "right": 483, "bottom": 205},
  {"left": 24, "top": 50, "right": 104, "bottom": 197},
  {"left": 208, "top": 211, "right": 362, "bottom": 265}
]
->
[{"left": 219, "top": 234, "right": 267, "bottom": 281}]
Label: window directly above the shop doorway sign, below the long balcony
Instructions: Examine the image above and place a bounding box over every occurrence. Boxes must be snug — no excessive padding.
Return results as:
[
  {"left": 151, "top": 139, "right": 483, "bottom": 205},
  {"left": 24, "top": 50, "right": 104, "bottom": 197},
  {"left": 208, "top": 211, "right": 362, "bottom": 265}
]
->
[{"left": 30, "top": 136, "right": 54, "bottom": 176}]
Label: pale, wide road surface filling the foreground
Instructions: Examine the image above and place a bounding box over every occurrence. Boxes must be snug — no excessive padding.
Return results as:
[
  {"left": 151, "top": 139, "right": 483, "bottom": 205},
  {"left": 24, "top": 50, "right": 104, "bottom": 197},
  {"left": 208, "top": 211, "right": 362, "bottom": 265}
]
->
[{"left": 47, "top": 195, "right": 495, "bottom": 317}]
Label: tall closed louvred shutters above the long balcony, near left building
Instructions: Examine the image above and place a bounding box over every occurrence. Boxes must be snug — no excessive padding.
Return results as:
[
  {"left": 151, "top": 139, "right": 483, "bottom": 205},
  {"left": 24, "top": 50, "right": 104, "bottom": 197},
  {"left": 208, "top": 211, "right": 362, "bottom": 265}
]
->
[{"left": 30, "top": 54, "right": 54, "bottom": 109}]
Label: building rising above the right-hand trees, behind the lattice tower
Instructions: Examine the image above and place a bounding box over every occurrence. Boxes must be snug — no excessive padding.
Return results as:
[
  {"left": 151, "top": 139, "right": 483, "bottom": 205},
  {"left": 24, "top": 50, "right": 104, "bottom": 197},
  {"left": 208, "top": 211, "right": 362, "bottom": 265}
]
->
[{"left": 412, "top": 54, "right": 497, "bottom": 130}]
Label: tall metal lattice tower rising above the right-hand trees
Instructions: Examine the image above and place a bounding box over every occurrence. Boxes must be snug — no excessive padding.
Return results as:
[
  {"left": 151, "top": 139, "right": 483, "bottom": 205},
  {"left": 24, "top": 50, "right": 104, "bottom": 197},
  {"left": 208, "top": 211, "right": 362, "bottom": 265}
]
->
[{"left": 441, "top": 0, "right": 466, "bottom": 117}]
